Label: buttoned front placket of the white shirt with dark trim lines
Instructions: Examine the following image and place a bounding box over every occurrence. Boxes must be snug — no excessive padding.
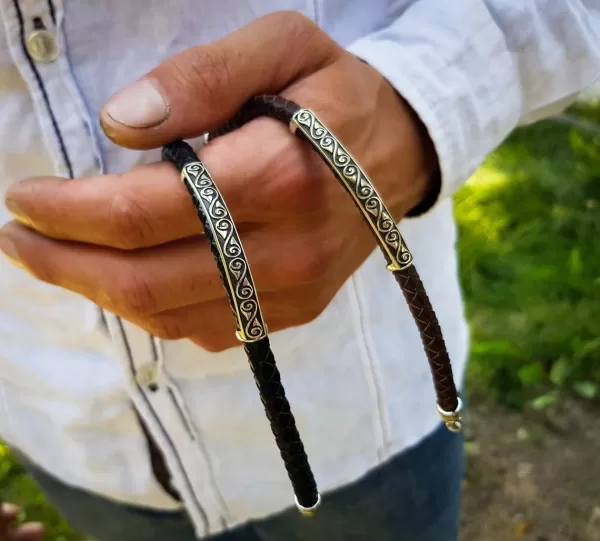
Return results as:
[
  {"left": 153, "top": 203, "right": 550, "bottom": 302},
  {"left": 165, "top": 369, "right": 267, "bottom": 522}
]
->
[{"left": 0, "top": 0, "right": 229, "bottom": 537}]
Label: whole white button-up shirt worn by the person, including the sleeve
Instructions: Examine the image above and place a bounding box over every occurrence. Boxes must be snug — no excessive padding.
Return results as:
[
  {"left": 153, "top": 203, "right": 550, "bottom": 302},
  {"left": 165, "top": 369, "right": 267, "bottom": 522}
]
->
[{"left": 0, "top": 0, "right": 600, "bottom": 537}]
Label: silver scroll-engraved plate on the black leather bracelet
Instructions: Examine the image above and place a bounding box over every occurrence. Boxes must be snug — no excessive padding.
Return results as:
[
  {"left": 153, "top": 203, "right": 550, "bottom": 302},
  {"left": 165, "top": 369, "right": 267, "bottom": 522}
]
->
[{"left": 181, "top": 162, "right": 268, "bottom": 342}]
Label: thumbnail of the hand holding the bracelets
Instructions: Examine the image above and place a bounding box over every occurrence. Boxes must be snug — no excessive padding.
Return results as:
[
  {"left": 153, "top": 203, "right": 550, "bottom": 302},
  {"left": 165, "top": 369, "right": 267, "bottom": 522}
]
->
[{"left": 105, "top": 79, "right": 169, "bottom": 128}]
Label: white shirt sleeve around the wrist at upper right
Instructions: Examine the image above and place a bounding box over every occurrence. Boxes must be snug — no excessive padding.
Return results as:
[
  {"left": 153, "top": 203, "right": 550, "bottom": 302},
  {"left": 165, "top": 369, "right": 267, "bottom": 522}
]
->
[{"left": 348, "top": 0, "right": 600, "bottom": 205}]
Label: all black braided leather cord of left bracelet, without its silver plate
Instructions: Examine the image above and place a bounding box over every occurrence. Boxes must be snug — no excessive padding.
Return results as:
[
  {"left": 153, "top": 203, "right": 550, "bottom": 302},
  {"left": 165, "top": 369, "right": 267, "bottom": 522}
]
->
[{"left": 163, "top": 141, "right": 319, "bottom": 508}]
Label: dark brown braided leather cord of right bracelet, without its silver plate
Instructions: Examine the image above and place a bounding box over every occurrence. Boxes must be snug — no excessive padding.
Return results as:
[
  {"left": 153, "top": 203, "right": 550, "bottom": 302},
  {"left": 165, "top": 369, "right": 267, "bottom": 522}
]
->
[{"left": 208, "top": 95, "right": 459, "bottom": 418}]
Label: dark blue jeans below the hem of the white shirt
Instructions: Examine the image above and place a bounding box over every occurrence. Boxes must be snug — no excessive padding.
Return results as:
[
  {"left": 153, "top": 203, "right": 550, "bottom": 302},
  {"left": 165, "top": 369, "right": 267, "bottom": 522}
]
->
[{"left": 15, "top": 427, "right": 464, "bottom": 541}]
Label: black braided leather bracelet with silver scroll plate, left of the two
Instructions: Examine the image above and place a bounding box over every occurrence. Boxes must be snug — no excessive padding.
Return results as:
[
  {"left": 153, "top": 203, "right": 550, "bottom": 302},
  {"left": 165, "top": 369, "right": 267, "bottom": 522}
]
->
[{"left": 163, "top": 141, "right": 321, "bottom": 515}]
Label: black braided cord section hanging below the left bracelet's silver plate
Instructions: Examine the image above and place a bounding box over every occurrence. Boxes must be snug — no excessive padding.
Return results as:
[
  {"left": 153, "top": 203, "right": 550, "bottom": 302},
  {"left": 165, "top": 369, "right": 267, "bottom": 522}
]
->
[{"left": 244, "top": 337, "right": 318, "bottom": 507}]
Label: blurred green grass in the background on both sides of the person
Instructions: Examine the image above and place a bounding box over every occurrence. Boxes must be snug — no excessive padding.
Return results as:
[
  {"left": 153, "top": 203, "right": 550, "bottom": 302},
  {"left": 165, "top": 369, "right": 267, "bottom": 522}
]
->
[{"left": 0, "top": 105, "right": 600, "bottom": 541}]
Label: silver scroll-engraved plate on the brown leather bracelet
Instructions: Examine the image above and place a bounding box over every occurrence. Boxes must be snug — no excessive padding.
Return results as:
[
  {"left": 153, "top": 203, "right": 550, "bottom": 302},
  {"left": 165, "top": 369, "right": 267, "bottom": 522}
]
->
[{"left": 292, "top": 109, "right": 413, "bottom": 271}]
